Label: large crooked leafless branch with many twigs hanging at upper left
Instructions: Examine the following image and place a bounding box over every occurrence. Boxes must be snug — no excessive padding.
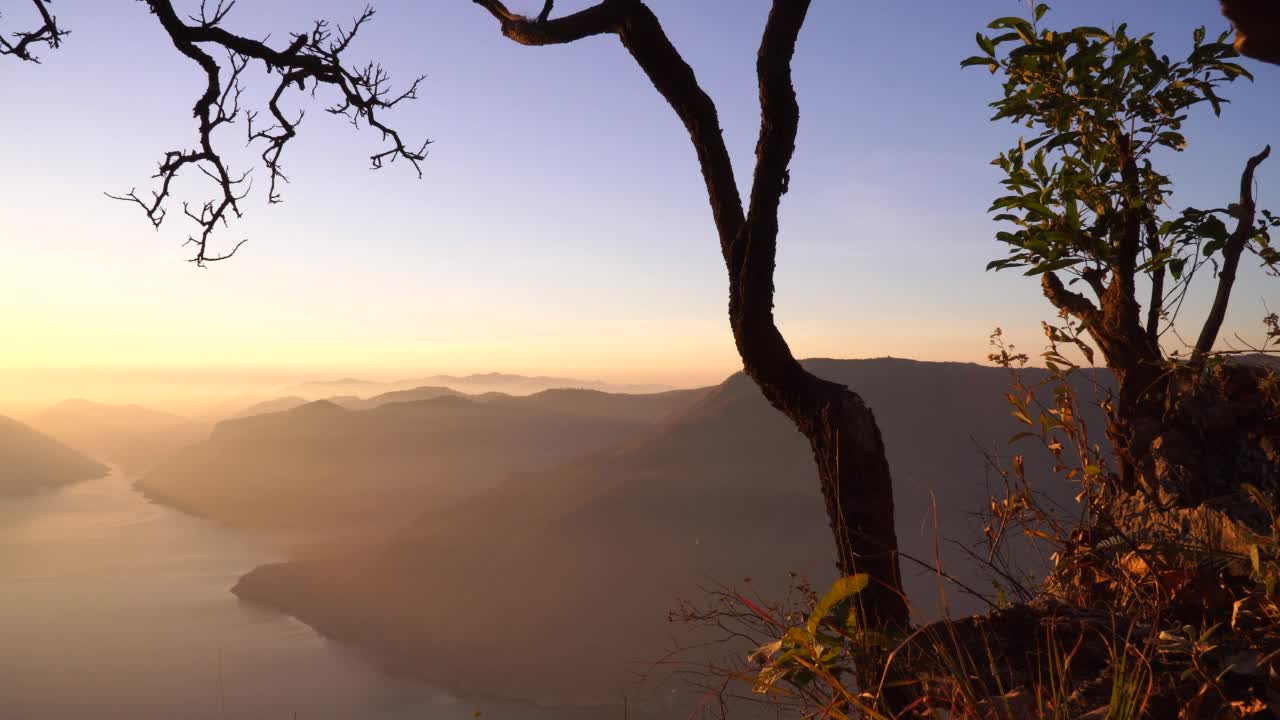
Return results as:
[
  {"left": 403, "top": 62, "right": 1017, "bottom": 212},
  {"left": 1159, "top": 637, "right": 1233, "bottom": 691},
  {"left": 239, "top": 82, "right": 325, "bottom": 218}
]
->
[{"left": 109, "top": 0, "right": 428, "bottom": 265}]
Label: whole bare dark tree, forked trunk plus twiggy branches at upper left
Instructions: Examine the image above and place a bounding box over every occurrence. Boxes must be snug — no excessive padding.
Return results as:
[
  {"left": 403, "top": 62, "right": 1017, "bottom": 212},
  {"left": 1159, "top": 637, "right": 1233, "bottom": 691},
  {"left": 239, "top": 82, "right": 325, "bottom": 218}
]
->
[{"left": 0, "top": 0, "right": 908, "bottom": 626}]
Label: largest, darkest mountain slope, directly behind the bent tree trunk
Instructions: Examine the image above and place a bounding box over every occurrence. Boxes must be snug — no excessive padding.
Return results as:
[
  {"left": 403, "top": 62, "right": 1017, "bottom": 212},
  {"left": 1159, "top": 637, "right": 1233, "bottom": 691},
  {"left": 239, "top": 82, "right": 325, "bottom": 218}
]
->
[{"left": 236, "top": 359, "right": 1100, "bottom": 702}]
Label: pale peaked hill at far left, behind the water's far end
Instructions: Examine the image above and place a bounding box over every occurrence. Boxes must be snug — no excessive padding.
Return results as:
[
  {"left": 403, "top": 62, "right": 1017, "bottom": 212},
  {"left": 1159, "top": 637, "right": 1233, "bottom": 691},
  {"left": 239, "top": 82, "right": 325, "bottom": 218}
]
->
[{"left": 28, "top": 400, "right": 209, "bottom": 474}]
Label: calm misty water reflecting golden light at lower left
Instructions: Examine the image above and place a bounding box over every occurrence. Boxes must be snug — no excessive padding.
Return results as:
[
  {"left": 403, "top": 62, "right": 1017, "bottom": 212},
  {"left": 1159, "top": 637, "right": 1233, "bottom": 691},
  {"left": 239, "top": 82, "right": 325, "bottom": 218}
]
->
[{"left": 0, "top": 473, "right": 524, "bottom": 720}]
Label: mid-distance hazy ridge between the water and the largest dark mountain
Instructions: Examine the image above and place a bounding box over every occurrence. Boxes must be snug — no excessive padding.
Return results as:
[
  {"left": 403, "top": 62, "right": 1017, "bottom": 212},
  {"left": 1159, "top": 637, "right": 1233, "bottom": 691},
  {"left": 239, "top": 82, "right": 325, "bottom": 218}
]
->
[{"left": 137, "top": 388, "right": 696, "bottom": 536}]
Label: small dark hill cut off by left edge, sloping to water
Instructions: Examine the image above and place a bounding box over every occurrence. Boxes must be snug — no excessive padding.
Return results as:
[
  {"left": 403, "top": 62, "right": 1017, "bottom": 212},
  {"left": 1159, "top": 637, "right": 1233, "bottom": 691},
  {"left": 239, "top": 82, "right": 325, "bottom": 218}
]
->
[{"left": 0, "top": 415, "right": 108, "bottom": 496}]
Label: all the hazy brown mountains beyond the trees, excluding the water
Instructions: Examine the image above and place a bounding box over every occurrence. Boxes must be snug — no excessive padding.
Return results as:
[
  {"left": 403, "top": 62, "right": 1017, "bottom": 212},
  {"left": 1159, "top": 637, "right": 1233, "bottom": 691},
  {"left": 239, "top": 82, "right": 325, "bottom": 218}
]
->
[{"left": 12, "top": 359, "right": 1101, "bottom": 703}]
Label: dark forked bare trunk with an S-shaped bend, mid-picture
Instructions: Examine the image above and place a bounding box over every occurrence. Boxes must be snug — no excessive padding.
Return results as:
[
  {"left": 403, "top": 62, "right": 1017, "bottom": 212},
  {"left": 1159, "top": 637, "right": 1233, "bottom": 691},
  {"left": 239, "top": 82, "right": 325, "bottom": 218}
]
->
[{"left": 474, "top": 0, "right": 909, "bottom": 626}]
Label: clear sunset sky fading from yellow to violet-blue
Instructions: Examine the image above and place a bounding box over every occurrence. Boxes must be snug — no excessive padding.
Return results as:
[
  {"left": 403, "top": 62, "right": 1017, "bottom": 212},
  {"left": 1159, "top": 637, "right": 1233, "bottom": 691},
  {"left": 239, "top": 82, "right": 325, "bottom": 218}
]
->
[{"left": 0, "top": 0, "right": 1280, "bottom": 402}]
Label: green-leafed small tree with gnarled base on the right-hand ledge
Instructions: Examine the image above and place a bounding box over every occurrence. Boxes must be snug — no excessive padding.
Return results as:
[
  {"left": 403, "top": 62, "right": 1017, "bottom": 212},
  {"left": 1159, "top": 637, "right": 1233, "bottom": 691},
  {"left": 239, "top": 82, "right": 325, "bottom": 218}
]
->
[{"left": 961, "top": 11, "right": 1280, "bottom": 502}]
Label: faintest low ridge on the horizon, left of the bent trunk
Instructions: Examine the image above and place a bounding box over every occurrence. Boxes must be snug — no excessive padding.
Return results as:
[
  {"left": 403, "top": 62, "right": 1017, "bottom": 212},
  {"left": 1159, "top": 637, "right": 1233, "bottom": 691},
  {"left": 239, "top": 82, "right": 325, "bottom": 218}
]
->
[{"left": 282, "top": 373, "right": 675, "bottom": 400}]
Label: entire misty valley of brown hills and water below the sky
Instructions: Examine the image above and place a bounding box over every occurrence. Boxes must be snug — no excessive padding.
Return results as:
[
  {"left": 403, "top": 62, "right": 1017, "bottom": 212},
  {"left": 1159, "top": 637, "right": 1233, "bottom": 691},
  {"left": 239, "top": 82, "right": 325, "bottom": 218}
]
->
[{"left": 0, "top": 359, "right": 1070, "bottom": 719}]
